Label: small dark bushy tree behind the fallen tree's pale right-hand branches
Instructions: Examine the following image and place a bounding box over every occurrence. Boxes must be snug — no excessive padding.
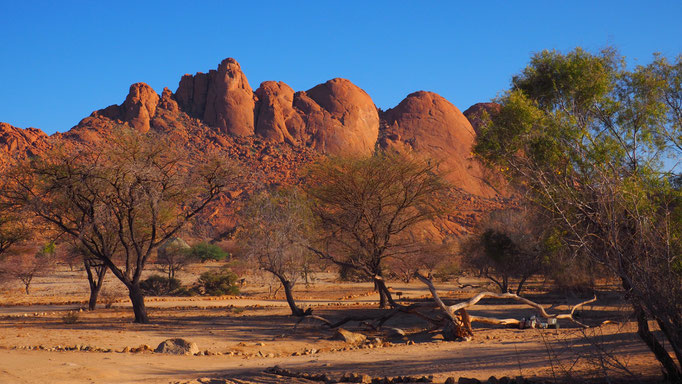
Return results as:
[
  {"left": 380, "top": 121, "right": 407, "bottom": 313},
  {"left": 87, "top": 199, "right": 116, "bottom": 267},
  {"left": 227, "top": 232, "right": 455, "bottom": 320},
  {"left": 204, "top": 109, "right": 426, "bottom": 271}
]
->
[{"left": 461, "top": 209, "right": 550, "bottom": 295}]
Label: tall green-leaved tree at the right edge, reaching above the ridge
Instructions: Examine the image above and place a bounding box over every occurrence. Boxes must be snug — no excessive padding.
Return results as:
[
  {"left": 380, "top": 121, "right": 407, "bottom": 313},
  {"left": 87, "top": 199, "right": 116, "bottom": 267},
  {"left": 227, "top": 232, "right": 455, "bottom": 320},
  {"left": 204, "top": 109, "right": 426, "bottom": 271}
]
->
[{"left": 476, "top": 49, "right": 682, "bottom": 380}]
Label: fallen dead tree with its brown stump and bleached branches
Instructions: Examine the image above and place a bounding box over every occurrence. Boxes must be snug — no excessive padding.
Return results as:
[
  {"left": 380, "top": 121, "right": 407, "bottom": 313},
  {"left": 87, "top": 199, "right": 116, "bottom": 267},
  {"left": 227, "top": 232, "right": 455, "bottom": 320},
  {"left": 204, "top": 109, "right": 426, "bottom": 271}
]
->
[{"left": 415, "top": 273, "right": 597, "bottom": 340}]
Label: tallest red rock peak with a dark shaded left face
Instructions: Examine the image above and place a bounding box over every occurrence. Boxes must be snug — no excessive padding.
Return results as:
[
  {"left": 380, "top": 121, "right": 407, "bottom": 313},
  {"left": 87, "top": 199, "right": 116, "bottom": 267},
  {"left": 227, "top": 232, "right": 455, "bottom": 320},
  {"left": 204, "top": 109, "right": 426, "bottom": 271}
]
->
[{"left": 176, "top": 58, "right": 255, "bottom": 136}]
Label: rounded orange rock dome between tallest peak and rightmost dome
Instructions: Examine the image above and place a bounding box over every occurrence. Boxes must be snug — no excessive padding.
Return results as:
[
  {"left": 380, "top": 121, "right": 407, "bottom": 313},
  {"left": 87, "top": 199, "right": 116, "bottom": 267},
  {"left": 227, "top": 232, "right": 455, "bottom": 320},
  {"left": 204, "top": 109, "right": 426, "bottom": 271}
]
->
[{"left": 294, "top": 78, "right": 379, "bottom": 155}]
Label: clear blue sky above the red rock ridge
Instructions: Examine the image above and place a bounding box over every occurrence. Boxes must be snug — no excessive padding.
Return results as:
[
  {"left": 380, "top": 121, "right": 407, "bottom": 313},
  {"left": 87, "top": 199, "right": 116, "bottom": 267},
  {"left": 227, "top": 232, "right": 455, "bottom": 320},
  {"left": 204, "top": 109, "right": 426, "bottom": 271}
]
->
[{"left": 0, "top": 0, "right": 682, "bottom": 133}]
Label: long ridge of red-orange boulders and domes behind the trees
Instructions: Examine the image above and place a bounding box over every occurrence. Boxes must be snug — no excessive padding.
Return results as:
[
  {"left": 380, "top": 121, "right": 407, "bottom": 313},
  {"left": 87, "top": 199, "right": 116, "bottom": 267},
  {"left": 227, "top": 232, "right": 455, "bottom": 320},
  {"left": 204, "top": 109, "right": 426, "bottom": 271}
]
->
[{"left": 0, "top": 58, "right": 505, "bottom": 236}]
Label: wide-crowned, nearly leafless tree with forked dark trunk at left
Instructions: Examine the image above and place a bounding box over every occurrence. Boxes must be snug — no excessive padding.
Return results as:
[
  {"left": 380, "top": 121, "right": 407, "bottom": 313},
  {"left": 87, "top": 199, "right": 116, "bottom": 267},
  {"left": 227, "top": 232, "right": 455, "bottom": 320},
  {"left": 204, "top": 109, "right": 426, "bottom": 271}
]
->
[{"left": 5, "top": 132, "right": 238, "bottom": 323}]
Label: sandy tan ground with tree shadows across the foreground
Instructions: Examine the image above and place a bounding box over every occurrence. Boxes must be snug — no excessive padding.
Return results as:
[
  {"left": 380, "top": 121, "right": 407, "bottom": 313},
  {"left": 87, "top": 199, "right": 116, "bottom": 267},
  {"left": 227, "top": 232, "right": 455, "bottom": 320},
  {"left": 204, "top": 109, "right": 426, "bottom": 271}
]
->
[{"left": 0, "top": 269, "right": 660, "bottom": 383}]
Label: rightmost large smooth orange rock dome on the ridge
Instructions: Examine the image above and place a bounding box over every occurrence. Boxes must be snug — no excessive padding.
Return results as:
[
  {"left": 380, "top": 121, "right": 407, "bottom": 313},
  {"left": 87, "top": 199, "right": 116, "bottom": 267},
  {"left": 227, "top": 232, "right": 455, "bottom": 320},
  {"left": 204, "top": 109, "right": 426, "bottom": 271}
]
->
[{"left": 379, "top": 91, "right": 494, "bottom": 196}]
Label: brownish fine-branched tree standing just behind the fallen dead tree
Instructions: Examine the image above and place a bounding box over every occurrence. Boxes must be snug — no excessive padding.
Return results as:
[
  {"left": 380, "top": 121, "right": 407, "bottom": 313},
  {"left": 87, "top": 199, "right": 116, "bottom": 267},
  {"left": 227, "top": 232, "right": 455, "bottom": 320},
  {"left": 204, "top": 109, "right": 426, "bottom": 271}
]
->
[{"left": 305, "top": 153, "right": 450, "bottom": 308}]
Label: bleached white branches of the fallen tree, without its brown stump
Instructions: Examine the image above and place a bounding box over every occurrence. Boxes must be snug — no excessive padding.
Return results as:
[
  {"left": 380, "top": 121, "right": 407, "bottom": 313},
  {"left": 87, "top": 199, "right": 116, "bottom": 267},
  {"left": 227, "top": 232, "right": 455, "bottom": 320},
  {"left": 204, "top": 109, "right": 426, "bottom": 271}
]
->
[{"left": 415, "top": 273, "right": 597, "bottom": 328}]
